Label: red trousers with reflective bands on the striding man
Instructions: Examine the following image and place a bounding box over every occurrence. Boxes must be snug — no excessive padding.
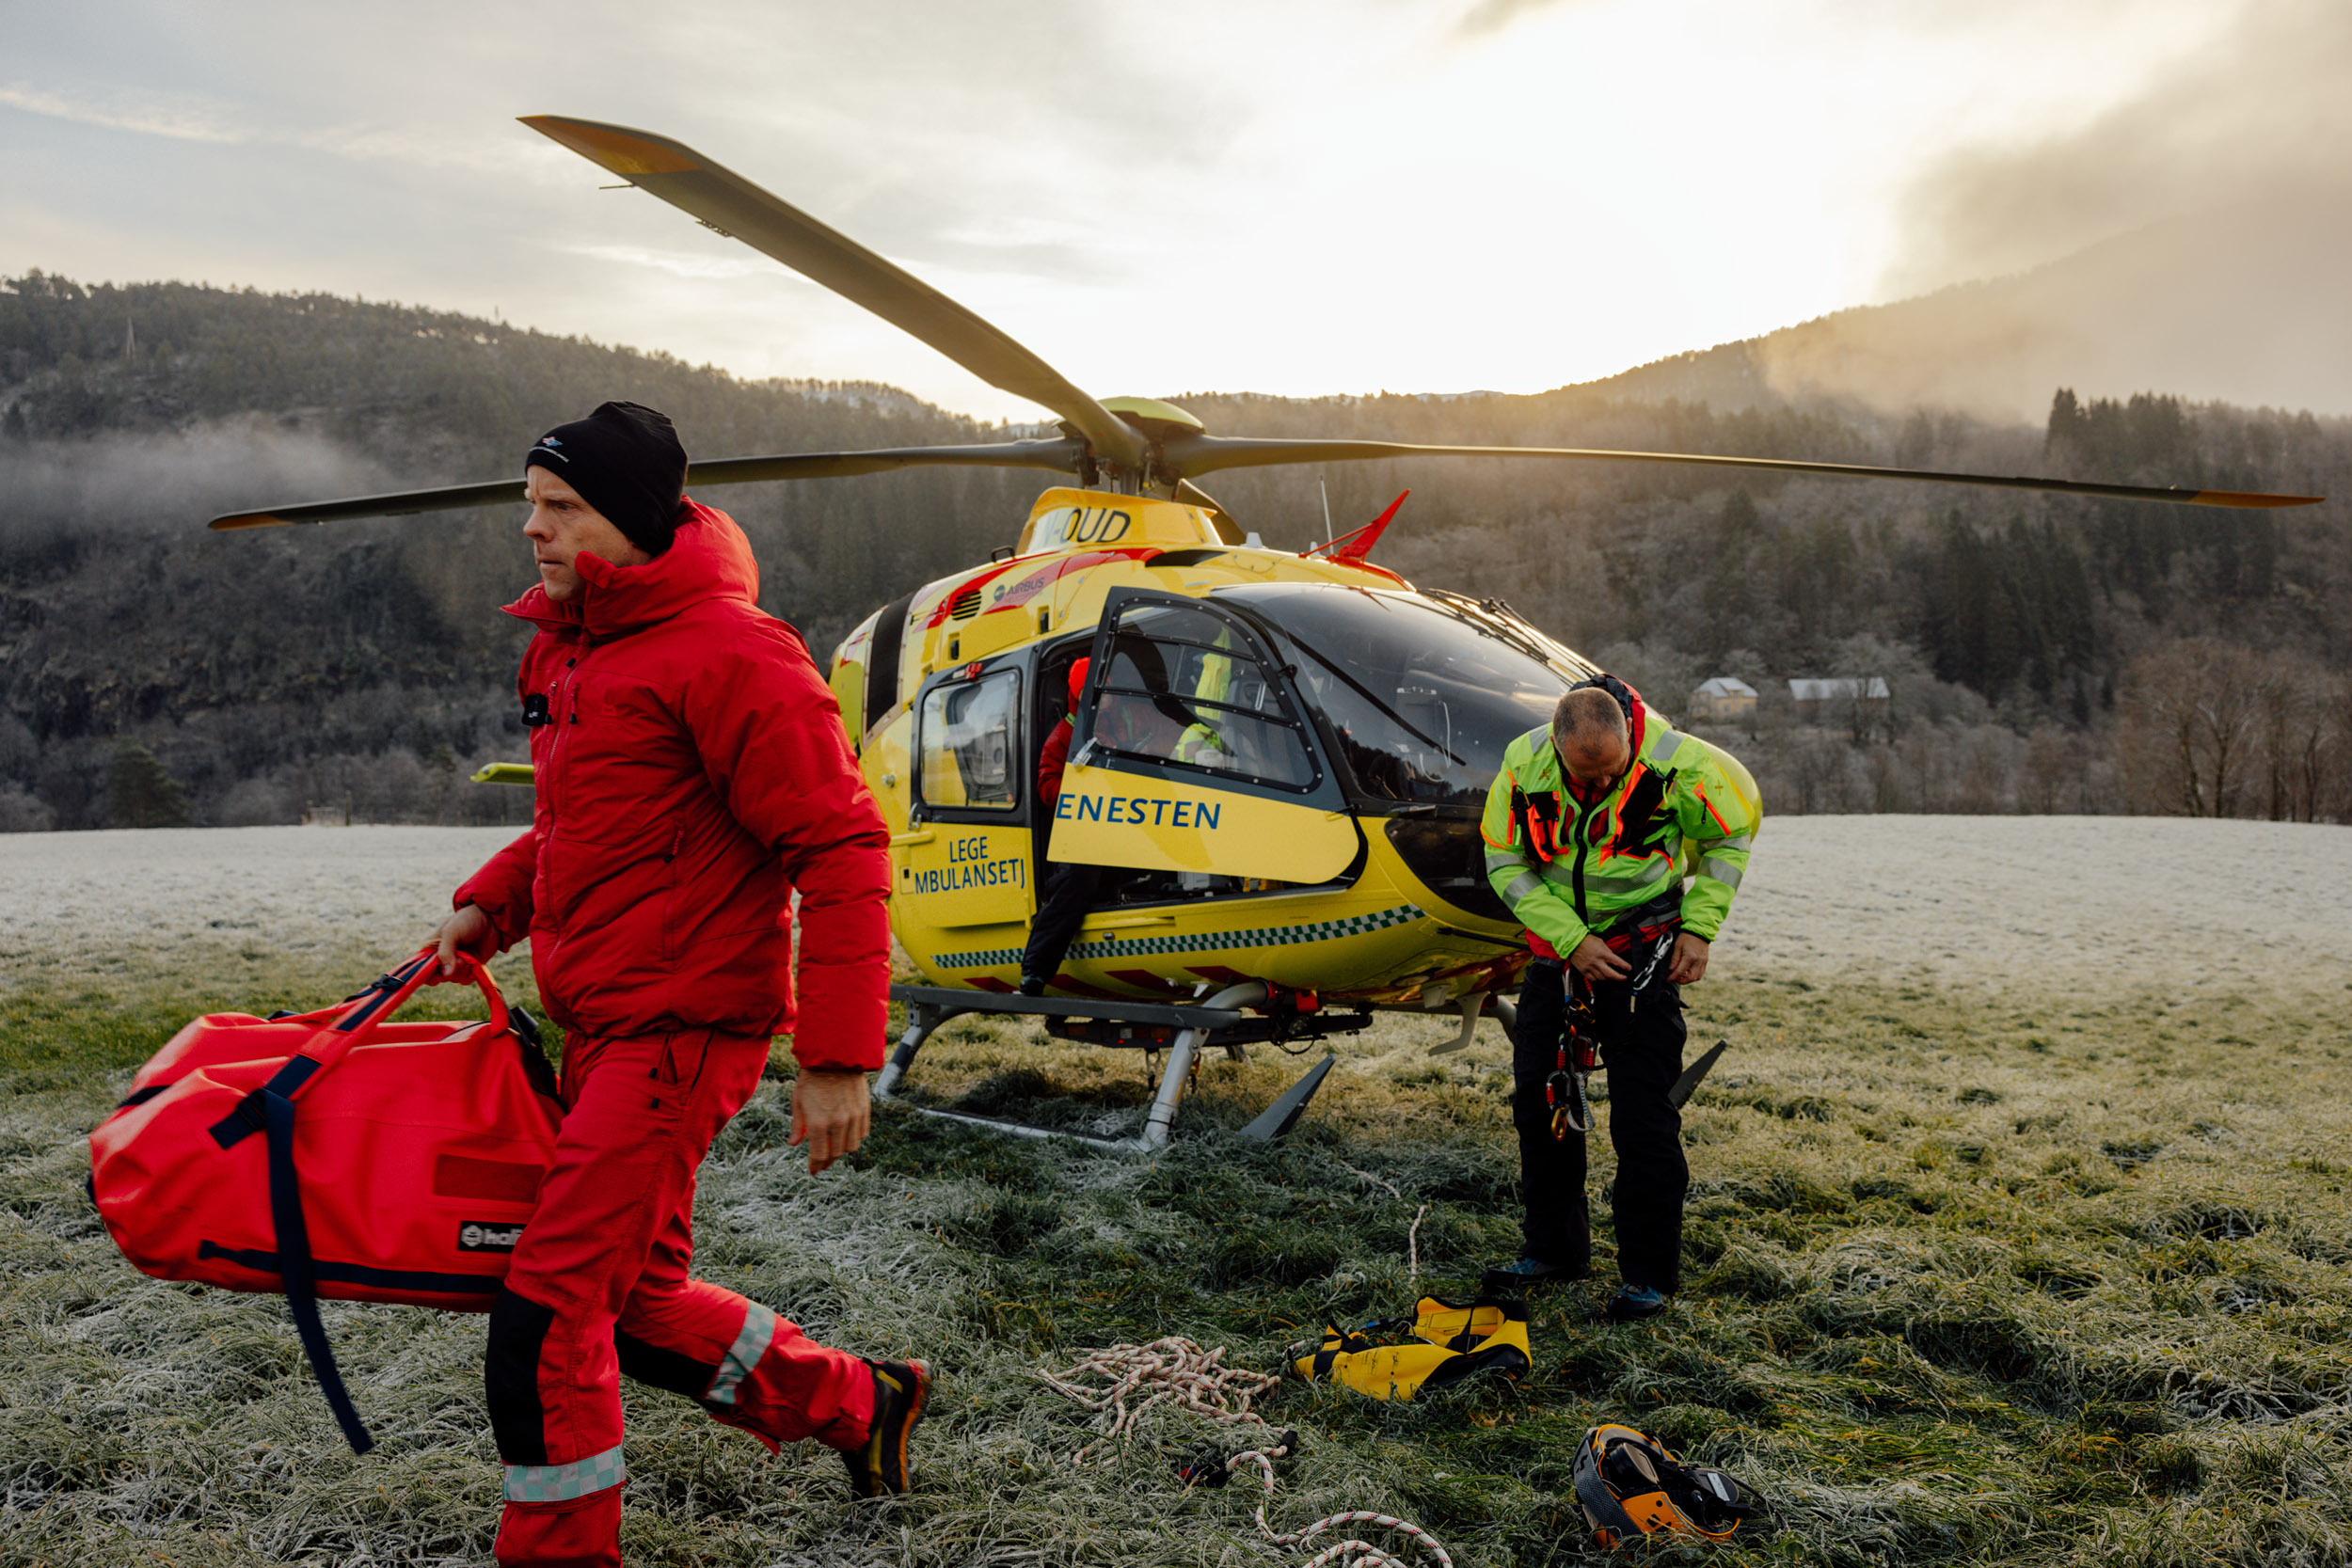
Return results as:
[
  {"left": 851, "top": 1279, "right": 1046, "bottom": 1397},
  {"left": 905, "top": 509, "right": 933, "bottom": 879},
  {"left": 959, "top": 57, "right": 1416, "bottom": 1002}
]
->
[{"left": 485, "top": 1030, "right": 873, "bottom": 1568}]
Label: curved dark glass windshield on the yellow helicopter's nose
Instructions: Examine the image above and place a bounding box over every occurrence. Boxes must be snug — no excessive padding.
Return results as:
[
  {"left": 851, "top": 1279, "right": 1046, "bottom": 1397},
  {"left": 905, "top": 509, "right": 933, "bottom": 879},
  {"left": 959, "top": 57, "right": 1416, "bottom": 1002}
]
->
[{"left": 1216, "top": 583, "right": 1569, "bottom": 806}]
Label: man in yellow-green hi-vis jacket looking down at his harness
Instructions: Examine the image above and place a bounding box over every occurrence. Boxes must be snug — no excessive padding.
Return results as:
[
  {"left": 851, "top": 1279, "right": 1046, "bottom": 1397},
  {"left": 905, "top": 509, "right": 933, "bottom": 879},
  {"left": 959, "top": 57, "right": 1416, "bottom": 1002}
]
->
[{"left": 1480, "top": 674, "right": 1764, "bottom": 1319}]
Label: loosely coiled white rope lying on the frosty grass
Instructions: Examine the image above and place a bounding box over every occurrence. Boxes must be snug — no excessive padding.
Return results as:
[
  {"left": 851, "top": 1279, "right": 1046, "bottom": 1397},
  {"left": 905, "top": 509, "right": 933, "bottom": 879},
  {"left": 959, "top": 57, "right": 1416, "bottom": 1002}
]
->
[{"left": 1030, "top": 1336, "right": 1454, "bottom": 1568}]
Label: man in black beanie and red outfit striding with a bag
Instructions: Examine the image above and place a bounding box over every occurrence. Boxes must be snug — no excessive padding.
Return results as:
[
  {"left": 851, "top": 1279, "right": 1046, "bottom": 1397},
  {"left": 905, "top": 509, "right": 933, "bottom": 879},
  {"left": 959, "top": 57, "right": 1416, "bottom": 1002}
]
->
[{"left": 440, "top": 402, "right": 930, "bottom": 1568}]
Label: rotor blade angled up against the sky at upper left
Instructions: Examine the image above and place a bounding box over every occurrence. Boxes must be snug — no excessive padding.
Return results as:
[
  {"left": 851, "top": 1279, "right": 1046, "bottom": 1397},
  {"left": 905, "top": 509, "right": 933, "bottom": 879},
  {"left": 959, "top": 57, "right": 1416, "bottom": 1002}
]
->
[{"left": 522, "top": 115, "right": 1143, "bottom": 470}]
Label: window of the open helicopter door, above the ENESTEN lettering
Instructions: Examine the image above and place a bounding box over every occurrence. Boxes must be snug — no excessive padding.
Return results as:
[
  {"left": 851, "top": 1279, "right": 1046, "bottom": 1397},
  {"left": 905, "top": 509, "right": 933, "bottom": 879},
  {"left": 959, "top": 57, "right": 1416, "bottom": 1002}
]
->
[{"left": 1094, "top": 604, "right": 1315, "bottom": 790}]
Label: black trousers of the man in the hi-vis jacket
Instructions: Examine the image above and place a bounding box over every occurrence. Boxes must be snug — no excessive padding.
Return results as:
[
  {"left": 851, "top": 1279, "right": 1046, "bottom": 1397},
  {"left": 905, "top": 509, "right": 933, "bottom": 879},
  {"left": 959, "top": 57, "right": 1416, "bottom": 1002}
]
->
[{"left": 1510, "top": 959, "right": 1692, "bottom": 1291}]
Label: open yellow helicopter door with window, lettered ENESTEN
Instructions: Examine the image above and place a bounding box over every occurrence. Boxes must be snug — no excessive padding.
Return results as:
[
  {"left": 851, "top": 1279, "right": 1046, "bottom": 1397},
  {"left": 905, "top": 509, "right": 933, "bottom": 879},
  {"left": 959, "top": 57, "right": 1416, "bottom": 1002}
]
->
[{"left": 1052, "top": 590, "right": 1362, "bottom": 884}]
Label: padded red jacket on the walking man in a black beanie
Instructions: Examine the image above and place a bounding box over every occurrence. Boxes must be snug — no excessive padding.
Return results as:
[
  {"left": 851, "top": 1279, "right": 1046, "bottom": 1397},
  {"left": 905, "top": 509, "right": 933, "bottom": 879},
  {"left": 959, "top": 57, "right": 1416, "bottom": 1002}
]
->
[{"left": 454, "top": 500, "right": 889, "bottom": 1068}]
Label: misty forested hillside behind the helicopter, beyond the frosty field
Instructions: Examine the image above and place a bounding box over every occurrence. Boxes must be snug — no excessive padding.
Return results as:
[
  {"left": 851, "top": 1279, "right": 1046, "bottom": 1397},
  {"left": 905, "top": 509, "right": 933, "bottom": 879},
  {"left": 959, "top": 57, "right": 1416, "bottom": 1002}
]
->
[{"left": 0, "top": 275, "right": 2352, "bottom": 828}]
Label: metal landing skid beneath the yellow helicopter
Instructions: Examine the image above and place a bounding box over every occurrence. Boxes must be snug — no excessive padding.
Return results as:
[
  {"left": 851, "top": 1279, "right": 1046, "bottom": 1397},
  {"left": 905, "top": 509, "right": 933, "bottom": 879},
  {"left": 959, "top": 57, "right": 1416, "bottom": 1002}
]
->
[{"left": 875, "top": 980, "right": 1372, "bottom": 1154}]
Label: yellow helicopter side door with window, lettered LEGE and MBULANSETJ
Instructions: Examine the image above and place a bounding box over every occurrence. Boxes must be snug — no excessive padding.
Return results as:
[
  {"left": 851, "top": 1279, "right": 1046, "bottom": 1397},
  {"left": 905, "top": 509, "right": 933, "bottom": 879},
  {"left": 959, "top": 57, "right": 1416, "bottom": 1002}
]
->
[{"left": 892, "top": 658, "right": 1038, "bottom": 927}]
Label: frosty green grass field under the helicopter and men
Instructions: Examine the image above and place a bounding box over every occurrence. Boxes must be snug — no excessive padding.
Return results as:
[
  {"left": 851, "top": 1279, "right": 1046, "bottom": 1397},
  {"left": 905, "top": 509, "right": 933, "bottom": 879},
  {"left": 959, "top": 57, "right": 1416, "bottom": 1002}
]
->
[{"left": 0, "top": 818, "right": 2352, "bottom": 1568}]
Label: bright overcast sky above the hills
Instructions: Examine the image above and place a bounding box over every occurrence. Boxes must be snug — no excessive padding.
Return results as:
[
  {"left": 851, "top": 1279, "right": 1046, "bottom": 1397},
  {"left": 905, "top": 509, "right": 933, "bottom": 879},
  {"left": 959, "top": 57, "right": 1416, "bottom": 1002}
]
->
[{"left": 0, "top": 0, "right": 2352, "bottom": 419}]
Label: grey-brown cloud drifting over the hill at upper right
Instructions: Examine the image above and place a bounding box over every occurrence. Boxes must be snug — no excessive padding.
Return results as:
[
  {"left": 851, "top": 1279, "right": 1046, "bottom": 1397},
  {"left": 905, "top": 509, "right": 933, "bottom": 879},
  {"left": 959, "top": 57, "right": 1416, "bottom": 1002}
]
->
[{"left": 1757, "top": 0, "right": 2352, "bottom": 419}]
